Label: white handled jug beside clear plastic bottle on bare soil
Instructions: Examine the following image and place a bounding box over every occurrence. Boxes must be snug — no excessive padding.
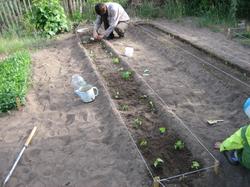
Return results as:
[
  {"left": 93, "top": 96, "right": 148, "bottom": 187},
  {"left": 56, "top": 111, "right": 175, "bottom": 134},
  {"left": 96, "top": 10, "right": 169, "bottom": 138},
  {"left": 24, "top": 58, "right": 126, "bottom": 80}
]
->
[{"left": 75, "top": 85, "right": 99, "bottom": 103}]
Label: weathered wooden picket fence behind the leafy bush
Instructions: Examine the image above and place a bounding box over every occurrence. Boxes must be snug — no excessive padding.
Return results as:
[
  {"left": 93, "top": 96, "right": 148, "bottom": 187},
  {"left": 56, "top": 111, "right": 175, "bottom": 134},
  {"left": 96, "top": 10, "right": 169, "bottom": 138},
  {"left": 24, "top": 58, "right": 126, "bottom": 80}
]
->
[{"left": 0, "top": 0, "right": 86, "bottom": 32}]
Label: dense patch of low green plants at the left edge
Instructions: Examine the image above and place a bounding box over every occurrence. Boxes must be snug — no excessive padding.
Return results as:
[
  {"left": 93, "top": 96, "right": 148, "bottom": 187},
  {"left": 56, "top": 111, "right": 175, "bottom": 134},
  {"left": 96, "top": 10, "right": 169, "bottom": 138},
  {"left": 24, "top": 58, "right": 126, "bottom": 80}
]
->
[{"left": 0, "top": 52, "right": 31, "bottom": 112}]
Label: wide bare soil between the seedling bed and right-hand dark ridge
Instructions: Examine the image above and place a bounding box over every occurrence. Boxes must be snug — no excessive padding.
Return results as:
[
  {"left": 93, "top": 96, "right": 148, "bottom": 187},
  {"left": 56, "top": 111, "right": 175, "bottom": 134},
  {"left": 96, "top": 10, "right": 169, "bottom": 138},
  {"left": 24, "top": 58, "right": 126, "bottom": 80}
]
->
[{"left": 105, "top": 23, "right": 250, "bottom": 186}]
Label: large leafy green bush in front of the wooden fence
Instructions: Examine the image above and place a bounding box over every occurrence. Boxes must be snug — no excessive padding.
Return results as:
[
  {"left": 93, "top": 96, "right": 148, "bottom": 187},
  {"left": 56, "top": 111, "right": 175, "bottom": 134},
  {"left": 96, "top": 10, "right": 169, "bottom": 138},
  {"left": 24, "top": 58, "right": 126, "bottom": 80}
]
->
[{"left": 27, "top": 0, "right": 68, "bottom": 37}]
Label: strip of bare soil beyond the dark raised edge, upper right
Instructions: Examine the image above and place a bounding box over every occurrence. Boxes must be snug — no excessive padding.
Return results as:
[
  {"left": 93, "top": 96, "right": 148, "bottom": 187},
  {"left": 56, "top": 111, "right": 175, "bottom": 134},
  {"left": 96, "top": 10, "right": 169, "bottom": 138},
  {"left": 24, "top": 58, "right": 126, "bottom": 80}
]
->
[{"left": 153, "top": 20, "right": 250, "bottom": 71}]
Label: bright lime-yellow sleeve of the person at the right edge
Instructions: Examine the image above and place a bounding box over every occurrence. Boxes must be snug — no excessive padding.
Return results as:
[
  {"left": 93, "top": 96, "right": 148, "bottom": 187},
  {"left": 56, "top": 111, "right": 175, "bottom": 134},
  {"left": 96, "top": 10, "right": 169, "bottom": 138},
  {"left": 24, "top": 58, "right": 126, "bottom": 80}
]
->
[{"left": 220, "top": 129, "right": 243, "bottom": 152}]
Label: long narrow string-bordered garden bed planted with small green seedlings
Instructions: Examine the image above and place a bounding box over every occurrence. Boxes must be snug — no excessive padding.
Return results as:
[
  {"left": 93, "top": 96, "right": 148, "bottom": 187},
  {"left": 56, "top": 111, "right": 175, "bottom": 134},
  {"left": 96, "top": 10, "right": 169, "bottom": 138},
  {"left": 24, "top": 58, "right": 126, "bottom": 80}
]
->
[{"left": 81, "top": 37, "right": 214, "bottom": 186}]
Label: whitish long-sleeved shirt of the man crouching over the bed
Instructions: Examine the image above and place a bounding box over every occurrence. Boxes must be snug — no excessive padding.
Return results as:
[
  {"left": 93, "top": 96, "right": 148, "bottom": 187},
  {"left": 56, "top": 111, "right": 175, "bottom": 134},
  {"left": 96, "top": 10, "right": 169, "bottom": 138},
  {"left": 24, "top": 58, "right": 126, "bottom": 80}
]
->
[{"left": 94, "top": 3, "right": 130, "bottom": 37}]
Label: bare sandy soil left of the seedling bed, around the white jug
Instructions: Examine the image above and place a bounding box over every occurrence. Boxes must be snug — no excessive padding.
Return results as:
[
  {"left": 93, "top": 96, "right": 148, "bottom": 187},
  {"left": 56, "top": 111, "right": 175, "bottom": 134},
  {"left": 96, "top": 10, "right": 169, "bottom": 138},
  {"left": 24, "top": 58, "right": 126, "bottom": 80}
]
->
[{"left": 0, "top": 36, "right": 150, "bottom": 187}]
